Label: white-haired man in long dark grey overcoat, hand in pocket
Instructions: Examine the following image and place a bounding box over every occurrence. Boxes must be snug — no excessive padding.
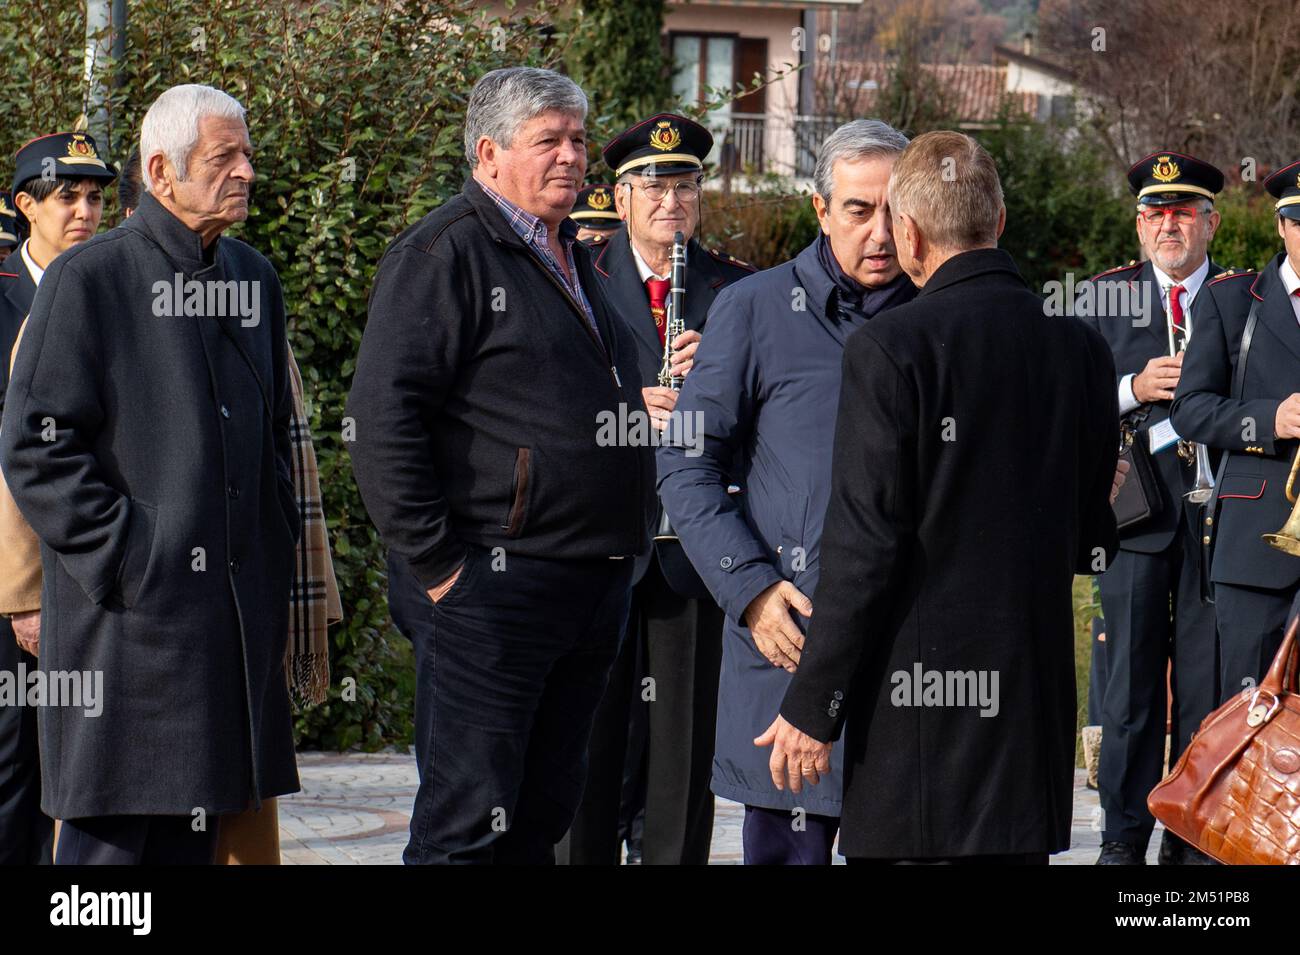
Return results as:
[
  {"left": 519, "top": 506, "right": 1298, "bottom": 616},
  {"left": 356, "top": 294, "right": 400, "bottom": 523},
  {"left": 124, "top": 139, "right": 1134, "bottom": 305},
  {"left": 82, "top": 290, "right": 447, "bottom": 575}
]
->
[{"left": 0, "top": 86, "right": 299, "bottom": 864}]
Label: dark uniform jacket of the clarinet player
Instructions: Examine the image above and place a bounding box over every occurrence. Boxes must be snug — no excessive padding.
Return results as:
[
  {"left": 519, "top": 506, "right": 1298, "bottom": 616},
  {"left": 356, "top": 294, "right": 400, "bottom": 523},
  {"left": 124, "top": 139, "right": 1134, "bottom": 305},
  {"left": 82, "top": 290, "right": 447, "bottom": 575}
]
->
[{"left": 592, "top": 225, "right": 754, "bottom": 581}]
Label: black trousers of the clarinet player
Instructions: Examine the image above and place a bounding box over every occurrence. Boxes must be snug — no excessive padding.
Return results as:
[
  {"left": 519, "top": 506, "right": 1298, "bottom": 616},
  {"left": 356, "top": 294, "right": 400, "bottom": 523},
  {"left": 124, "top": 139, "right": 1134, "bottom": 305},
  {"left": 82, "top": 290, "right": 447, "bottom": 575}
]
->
[{"left": 559, "top": 560, "right": 723, "bottom": 865}]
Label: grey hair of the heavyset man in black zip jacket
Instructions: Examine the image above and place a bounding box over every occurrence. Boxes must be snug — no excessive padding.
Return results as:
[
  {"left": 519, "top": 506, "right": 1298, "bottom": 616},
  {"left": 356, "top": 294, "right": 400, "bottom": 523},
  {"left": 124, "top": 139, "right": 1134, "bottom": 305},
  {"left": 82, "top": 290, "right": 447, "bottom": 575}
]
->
[{"left": 465, "top": 66, "right": 586, "bottom": 169}]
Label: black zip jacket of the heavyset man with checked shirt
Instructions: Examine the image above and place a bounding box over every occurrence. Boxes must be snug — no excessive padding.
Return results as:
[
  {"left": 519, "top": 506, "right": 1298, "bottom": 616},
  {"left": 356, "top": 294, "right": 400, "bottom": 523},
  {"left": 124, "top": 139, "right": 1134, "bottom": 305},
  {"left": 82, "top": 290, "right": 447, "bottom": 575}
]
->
[{"left": 348, "top": 179, "right": 654, "bottom": 589}]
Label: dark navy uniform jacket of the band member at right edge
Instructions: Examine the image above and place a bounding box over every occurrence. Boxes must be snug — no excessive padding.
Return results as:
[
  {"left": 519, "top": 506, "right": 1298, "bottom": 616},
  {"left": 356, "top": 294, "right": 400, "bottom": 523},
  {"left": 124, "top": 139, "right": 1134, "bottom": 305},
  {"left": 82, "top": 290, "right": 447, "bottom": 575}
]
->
[{"left": 1174, "top": 255, "right": 1300, "bottom": 590}]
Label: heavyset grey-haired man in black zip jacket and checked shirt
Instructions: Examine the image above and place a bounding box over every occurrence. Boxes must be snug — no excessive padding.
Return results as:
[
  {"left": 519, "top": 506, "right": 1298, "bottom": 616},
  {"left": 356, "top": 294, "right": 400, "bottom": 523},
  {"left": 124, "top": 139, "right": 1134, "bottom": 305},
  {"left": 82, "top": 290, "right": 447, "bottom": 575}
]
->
[{"left": 348, "top": 66, "right": 654, "bottom": 864}]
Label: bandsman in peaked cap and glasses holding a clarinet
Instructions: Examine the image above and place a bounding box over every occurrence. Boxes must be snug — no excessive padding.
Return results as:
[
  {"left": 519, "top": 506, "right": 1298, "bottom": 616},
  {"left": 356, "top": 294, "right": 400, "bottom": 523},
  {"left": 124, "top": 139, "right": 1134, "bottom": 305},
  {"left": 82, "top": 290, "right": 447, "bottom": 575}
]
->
[{"left": 560, "top": 113, "right": 754, "bottom": 865}]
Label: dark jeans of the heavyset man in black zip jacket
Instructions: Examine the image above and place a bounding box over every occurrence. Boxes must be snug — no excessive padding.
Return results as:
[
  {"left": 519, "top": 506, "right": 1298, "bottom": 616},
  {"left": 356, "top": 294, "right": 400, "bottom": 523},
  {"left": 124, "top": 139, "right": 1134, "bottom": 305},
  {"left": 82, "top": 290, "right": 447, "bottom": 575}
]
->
[{"left": 403, "top": 546, "right": 632, "bottom": 865}]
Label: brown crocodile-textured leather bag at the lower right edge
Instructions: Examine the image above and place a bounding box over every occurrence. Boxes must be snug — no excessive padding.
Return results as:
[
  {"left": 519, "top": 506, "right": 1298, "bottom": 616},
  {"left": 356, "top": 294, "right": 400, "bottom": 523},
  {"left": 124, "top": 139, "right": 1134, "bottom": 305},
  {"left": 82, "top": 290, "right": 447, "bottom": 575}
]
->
[{"left": 1149, "top": 616, "right": 1300, "bottom": 865}]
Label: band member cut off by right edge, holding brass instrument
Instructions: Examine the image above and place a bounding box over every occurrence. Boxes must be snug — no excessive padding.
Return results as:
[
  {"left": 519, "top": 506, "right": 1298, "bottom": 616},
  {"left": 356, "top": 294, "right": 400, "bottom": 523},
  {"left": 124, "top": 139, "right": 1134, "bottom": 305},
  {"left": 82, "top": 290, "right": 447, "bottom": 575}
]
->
[{"left": 1174, "top": 162, "right": 1300, "bottom": 722}]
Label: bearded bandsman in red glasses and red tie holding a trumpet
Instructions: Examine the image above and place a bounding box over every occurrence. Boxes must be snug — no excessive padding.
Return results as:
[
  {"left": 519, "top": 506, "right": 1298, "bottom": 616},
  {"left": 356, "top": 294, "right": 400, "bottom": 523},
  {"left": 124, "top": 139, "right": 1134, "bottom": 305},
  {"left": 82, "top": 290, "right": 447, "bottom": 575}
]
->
[{"left": 1080, "top": 151, "right": 1222, "bottom": 865}]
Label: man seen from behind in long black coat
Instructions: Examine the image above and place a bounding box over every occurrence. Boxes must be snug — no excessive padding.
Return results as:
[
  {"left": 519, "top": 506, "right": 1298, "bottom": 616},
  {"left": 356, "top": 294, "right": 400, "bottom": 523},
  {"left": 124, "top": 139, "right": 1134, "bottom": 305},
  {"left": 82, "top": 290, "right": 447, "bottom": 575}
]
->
[{"left": 755, "top": 131, "right": 1119, "bottom": 863}]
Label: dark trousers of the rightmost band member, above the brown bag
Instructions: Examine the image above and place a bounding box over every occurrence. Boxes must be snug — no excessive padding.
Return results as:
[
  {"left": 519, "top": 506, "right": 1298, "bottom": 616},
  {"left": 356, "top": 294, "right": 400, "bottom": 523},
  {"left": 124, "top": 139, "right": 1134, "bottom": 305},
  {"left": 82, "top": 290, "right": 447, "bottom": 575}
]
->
[{"left": 1214, "top": 583, "right": 1296, "bottom": 703}]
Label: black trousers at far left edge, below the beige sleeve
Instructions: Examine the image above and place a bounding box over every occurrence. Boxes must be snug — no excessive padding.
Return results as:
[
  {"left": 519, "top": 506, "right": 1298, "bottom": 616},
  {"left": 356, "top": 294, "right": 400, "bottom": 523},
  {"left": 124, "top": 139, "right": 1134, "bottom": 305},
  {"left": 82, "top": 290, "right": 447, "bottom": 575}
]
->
[{"left": 0, "top": 617, "right": 55, "bottom": 865}]
